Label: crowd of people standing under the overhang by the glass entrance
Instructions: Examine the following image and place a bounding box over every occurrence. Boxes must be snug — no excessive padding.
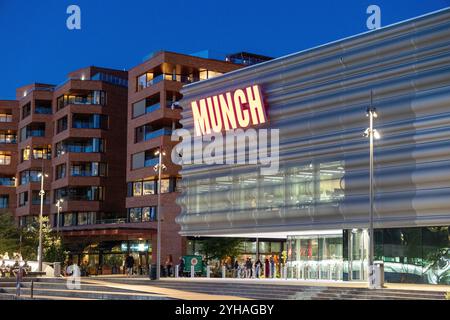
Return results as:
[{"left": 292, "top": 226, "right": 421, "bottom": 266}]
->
[{"left": 227, "top": 255, "right": 279, "bottom": 278}]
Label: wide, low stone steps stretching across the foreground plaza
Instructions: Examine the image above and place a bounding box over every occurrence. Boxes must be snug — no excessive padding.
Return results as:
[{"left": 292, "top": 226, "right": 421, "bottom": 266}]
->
[{"left": 0, "top": 277, "right": 445, "bottom": 300}]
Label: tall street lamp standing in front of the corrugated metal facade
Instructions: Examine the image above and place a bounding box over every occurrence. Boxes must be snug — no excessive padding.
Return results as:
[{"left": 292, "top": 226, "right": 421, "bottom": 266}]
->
[{"left": 364, "top": 91, "right": 381, "bottom": 289}]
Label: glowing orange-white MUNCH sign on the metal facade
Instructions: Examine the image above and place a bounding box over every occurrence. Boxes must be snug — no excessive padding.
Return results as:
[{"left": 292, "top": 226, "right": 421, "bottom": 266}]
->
[{"left": 191, "top": 85, "right": 267, "bottom": 136}]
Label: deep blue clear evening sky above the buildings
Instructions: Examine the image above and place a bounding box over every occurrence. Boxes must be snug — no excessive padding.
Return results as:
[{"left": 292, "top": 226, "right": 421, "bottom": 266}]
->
[{"left": 0, "top": 0, "right": 450, "bottom": 99}]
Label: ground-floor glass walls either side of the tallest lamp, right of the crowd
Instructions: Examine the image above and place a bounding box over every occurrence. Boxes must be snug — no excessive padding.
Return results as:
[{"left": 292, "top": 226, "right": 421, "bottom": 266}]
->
[{"left": 286, "top": 226, "right": 450, "bottom": 285}]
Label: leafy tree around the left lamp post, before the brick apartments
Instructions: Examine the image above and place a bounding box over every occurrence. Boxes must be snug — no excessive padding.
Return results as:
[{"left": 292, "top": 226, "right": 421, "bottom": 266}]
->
[{"left": 22, "top": 217, "right": 67, "bottom": 262}]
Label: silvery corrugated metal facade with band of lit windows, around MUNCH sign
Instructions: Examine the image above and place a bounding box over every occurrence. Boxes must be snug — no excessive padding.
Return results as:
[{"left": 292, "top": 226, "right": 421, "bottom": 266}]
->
[{"left": 177, "top": 10, "right": 450, "bottom": 235}]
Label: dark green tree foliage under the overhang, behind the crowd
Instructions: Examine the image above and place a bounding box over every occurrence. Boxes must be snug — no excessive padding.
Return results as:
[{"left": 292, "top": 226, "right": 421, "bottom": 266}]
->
[{"left": 200, "top": 238, "right": 243, "bottom": 261}]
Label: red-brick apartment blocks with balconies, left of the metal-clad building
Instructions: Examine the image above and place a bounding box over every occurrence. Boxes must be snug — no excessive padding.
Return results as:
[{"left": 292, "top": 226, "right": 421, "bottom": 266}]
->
[{"left": 0, "top": 51, "right": 268, "bottom": 274}]
